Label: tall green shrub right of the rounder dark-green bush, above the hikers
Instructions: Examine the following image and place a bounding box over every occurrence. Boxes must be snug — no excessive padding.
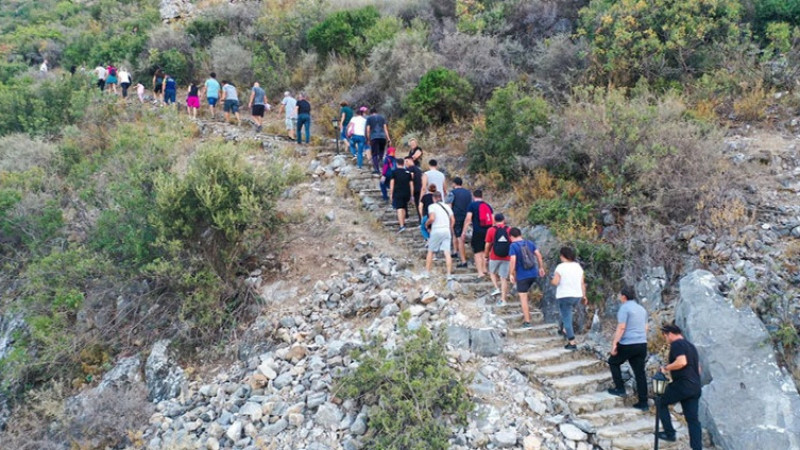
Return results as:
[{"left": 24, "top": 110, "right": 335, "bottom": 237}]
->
[{"left": 467, "top": 83, "right": 550, "bottom": 181}]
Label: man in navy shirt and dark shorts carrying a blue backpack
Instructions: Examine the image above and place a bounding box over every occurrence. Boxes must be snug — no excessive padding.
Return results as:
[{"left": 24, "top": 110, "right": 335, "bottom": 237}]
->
[{"left": 508, "top": 227, "right": 544, "bottom": 328}]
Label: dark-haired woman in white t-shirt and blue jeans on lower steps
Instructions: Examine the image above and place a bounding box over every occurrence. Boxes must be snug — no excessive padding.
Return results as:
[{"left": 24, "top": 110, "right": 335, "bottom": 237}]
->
[{"left": 550, "top": 247, "right": 589, "bottom": 350}]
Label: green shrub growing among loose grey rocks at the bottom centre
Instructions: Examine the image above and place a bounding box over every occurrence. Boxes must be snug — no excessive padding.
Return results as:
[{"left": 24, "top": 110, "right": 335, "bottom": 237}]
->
[{"left": 337, "top": 312, "right": 473, "bottom": 450}]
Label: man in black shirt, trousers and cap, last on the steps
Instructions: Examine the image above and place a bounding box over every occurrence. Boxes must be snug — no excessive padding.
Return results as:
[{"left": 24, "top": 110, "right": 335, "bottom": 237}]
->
[{"left": 656, "top": 324, "right": 703, "bottom": 450}]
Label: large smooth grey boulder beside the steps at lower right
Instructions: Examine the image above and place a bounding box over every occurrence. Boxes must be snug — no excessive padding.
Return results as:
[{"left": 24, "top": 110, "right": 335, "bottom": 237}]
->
[{"left": 675, "top": 270, "right": 800, "bottom": 450}]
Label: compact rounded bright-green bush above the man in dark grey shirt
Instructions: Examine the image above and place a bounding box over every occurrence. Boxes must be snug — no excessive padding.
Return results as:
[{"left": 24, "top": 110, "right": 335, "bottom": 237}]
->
[{"left": 403, "top": 68, "right": 472, "bottom": 129}]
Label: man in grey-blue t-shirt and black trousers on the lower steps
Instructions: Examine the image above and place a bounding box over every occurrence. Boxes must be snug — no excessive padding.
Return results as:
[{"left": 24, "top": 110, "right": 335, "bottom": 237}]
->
[{"left": 608, "top": 286, "right": 648, "bottom": 411}]
